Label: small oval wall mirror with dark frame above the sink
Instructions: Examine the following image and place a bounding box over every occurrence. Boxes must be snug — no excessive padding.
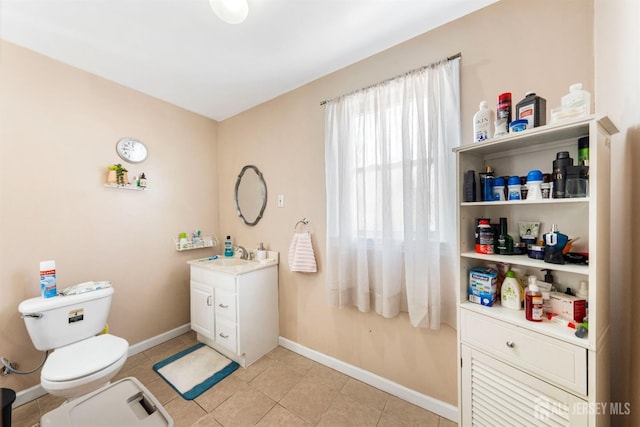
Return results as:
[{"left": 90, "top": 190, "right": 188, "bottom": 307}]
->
[{"left": 234, "top": 165, "right": 267, "bottom": 225}]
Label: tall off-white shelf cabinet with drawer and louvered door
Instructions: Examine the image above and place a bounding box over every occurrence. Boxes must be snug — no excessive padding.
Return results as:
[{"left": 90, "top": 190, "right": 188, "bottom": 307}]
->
[{"left": 454, "top": 115, "right": 617, "bottom": 427}]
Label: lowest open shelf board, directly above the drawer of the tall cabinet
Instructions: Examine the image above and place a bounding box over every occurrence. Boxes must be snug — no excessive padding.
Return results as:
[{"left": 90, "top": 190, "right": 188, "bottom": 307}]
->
[{"left": 460, "top": 301, "right": 593, "bottom": 349}]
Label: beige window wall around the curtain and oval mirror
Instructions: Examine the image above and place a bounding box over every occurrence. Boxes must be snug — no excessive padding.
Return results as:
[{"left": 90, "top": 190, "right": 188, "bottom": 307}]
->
[{"left": 219, "top": 0, "right": 593, "bottom": 405}]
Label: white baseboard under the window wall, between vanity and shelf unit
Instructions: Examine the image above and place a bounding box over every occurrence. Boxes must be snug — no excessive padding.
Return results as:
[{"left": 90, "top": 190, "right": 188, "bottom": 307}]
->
[{"left": 278, "top": 337, "right": 458, "bottom": 423}]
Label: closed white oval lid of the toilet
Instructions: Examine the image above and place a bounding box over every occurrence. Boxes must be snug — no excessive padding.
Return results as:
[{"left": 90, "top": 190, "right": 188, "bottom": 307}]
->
[{"left": 41, "top": 334, "right": 129, "bottom": 381}]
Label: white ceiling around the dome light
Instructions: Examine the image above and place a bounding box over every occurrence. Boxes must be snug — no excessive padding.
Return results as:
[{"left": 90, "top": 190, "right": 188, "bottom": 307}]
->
[{"left": 0, "top": 0, "right": 497, "bottom": 120}]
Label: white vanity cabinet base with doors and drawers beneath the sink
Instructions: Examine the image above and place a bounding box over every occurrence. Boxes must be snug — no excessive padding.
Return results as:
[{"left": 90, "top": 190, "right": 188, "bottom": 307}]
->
[{"left": 190, "top": 262, "right": 279, "bottom": 367}]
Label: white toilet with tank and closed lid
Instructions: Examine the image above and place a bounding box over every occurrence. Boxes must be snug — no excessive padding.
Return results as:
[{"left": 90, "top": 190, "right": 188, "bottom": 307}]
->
[{"left": 18, "top": 287, "right": 129, "bottom": 401}]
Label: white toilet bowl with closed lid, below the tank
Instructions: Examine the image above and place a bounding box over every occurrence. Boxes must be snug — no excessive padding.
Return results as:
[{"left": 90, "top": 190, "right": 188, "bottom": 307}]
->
[{"left": 40, "top": 334, "right": 129, "bottom": 398}]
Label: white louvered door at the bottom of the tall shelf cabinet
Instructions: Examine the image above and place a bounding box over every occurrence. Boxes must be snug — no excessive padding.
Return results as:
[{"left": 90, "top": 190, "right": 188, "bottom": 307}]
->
[{"left": 460, "top": 344, "right": 589, "bottom": 426}]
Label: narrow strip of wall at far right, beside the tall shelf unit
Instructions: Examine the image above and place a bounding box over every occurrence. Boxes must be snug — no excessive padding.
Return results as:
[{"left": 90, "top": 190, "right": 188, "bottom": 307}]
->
[{"left": 595, "top": 0, "right": 640, "bottom": 426}]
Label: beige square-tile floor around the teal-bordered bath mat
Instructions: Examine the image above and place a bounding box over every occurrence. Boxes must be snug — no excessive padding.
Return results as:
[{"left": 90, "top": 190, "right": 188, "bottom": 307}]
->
[{"left": 12, "top": 332, "right": 456, "bottom": 427}]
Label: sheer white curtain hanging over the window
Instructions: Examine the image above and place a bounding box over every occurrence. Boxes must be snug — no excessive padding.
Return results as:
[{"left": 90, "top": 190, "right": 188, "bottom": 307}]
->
[{"left": 325, "top": 58, "right": 460, "bottom": 329}]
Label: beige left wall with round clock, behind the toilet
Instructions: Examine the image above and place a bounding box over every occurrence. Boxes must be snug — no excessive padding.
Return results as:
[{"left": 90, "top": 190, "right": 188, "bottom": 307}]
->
[{"left": 0, "top": 42, "right": 218, "bottom": 391}]
